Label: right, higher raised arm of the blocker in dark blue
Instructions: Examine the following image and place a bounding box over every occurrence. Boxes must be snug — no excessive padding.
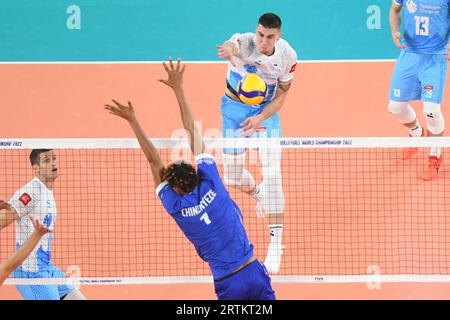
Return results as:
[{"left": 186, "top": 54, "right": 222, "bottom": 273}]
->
[{"left": 159, "top": 58, "right": 206, "bottom": 156}]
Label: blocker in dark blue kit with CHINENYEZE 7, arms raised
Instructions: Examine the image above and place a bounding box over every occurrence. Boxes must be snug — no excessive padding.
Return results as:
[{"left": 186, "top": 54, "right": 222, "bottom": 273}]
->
[{"left": 105, "top": 59, "right": 275, "bottom": 300}]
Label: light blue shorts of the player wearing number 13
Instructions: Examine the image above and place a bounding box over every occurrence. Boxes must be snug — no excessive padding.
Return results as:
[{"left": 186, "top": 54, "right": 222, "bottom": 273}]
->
[{"left": 389, "top": 50, "right": 447, "bottom": 104}]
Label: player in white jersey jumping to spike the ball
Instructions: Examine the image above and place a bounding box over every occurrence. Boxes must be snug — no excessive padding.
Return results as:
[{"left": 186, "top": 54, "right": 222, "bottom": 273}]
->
[{"left": 217, "top": 13, "right": 297, "bottom": 273}]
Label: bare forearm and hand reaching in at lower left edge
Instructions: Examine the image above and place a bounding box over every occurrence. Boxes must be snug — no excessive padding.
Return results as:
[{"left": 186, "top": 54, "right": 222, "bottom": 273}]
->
[{"left": 0, "top": 215, "right": 51, "bottom": 286}]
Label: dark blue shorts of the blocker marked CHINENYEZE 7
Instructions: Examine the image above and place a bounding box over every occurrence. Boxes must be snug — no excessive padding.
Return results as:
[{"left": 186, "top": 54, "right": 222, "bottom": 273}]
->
[{"left": 214, "top": 259, "right": 275, "bottom": 300}]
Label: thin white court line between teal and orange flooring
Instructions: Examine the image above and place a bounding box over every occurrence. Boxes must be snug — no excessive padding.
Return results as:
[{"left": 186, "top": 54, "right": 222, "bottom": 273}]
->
[{"left": 0, "top": 59, "right": 396, "bottom": 65}]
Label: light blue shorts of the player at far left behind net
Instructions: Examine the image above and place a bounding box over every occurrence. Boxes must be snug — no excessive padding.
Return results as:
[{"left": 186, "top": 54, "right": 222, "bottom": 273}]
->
[{"left": 12, "top": 264, "right": 75, "bottom": 300}]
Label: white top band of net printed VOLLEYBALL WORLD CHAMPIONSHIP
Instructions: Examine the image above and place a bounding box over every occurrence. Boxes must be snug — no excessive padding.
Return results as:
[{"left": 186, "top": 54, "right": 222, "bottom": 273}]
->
[{"left": 0, "top": 137, "right": 450, "bottom": 150}]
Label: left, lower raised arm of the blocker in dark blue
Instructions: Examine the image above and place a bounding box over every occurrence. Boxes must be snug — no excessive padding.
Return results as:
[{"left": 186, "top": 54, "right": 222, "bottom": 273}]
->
[{"left": 105, "top": 100, "right": 164, "bottom": 186}]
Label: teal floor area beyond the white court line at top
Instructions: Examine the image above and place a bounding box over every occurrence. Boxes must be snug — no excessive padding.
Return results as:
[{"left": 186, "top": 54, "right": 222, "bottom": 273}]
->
[{"left": 0, "top": 0, "right": 397, "bottom": 61}]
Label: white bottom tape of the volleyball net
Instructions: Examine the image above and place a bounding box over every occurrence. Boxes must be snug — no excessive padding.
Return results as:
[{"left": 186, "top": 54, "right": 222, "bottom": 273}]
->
[{"left": 5, "top": 275, "right": 450, "bottom": 285}]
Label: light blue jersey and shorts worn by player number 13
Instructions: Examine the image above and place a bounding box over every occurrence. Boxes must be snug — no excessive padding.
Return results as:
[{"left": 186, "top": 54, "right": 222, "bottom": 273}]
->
[{"left": 389, "top": 0, "right": 450, "bottom": 104}]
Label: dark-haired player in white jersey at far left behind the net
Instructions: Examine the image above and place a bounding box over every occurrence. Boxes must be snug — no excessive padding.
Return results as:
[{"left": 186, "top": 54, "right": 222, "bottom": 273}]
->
[{"left": 0, "top": 149, "right": 85, "bottom": 300}]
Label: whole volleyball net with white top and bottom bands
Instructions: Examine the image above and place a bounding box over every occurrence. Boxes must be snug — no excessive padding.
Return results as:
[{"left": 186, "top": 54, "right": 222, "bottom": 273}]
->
[{"left": 0, "top": 137, "right": 450, "bottom": 284}]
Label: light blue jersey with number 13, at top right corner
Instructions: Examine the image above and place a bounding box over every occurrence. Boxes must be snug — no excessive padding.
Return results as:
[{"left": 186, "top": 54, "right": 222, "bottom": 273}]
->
[{"left": 394, "top": 0, "right": 450, "bottom": 54}]
